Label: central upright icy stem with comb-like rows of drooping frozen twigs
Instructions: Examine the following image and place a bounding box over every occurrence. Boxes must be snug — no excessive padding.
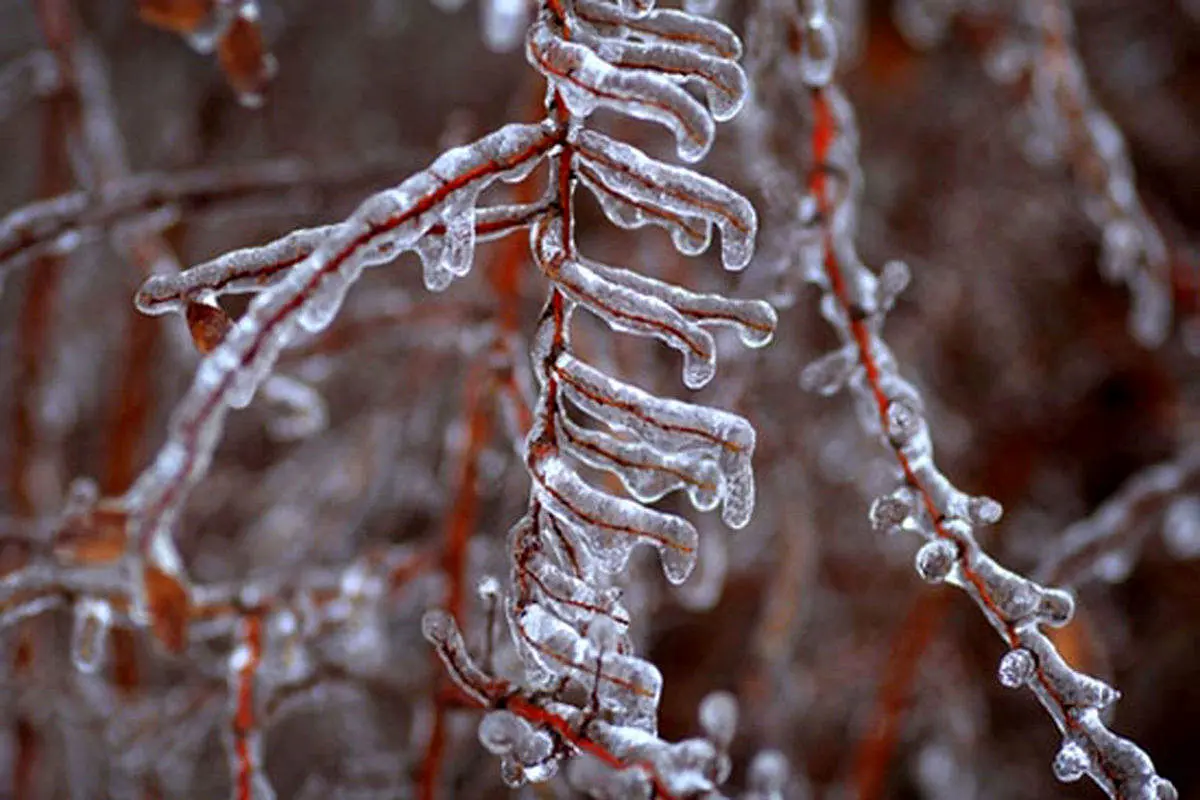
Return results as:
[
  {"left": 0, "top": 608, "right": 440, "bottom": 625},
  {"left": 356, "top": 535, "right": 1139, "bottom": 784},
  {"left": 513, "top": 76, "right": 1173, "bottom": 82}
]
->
[{"left": 408, "top": 0, "right": 775, "bottom": 798}]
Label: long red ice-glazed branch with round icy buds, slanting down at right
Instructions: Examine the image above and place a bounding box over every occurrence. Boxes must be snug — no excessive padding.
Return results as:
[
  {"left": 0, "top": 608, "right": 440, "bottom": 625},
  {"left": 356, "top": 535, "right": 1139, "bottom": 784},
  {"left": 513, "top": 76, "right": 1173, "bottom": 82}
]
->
[{"left": 796, "top": 0, "right": 1176, "bottom": 800}]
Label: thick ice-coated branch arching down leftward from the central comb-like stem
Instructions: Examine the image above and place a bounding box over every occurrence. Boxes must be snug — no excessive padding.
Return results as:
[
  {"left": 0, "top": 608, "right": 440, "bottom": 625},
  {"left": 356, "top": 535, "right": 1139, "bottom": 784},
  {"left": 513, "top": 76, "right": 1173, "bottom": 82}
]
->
[{"left": 114, "top": 118, "right": 560, "bottom": 652}]
